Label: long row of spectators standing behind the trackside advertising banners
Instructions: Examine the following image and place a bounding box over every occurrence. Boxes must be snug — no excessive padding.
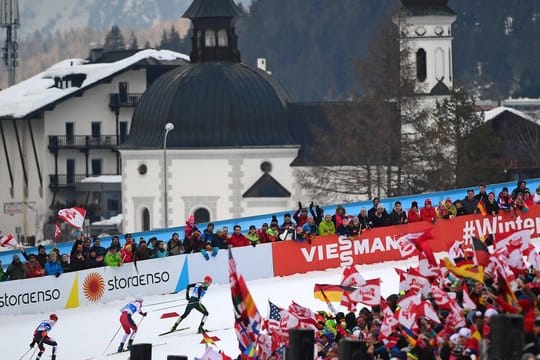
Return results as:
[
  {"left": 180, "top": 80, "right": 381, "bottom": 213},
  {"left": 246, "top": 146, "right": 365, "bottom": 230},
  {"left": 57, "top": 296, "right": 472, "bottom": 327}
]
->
[{"left": 0, "top": 180, "right": 540, "bottom": 281}]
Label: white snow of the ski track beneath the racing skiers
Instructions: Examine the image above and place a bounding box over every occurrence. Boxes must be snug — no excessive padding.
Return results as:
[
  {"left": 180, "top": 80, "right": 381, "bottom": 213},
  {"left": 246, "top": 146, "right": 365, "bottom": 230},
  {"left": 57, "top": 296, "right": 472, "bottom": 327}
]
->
[{"left": 0, "top": 258, "right": 417, "bottom": 360}]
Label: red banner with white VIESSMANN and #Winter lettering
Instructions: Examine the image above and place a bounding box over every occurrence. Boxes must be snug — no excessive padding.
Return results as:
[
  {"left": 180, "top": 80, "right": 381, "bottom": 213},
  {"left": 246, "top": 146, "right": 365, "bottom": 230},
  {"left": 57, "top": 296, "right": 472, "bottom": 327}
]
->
[{"left": 272, "top": 206, "right": 540, "bottom": 276}]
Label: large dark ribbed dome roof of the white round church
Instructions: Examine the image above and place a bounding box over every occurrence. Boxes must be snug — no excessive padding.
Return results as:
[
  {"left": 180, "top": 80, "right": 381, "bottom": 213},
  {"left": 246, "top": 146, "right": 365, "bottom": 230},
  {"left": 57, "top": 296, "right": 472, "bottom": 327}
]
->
[{"left": 123, "top": 62, "right": 295, "bottom": 148}]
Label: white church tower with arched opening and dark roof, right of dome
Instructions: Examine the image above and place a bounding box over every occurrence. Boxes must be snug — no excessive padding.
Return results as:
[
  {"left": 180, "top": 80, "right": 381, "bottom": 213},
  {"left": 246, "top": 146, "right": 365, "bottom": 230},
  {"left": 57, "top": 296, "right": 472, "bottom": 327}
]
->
[{"left": 394, "top": 0, "right": 456, "bottom": 96}]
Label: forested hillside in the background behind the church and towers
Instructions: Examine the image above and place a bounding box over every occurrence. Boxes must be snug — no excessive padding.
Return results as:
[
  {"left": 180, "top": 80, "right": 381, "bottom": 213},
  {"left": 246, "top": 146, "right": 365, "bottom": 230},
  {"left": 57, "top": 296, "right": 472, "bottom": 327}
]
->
[{"left": 0, "top": 0, "right": 540, "bottom": 101}]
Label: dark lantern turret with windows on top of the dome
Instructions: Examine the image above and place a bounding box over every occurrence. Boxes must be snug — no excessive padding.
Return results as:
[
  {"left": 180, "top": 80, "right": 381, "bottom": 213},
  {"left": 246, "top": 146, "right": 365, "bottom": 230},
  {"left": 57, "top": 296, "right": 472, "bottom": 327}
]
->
[{"left": 182, "top": 0, "right": 244, "bottom": 63}]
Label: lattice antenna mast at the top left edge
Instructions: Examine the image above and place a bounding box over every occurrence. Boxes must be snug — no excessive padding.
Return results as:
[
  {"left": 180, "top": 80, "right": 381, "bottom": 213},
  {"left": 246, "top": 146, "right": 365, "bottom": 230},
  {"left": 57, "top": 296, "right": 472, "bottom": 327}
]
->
[{"left": 0, "top": 0, "right": 19, "bottom": 86}]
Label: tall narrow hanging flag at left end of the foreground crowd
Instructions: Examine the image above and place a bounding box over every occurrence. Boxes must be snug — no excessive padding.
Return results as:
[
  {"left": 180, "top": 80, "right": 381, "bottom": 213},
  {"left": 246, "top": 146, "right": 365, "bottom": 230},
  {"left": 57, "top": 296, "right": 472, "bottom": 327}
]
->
[{"left": 229, "top": 249, "right": 262, "bottom": 353}]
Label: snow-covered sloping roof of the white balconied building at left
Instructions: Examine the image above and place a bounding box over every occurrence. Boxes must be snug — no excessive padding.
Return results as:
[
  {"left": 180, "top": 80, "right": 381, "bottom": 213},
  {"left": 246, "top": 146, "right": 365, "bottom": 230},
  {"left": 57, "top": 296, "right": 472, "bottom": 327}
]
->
[{"left": 0, "top": 49, "right": 189, "bottom": 118}]
